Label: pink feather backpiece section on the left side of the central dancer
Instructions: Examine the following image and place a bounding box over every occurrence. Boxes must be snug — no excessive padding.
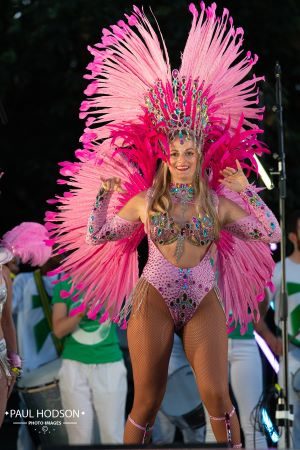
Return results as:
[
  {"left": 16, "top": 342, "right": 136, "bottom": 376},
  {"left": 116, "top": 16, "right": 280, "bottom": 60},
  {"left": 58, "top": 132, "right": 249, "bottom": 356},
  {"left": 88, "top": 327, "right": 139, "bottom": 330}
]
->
[{"left": 46, "top": 122, "right": 167, "bottom": 322}]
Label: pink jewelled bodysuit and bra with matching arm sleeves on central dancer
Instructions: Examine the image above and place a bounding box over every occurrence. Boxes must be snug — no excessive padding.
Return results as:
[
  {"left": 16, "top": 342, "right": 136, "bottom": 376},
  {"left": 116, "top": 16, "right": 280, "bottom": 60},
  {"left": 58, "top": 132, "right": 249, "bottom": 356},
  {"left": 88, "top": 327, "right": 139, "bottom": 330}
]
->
[{"left": 86, "top": 187, "right": 279, "bottom": 329}]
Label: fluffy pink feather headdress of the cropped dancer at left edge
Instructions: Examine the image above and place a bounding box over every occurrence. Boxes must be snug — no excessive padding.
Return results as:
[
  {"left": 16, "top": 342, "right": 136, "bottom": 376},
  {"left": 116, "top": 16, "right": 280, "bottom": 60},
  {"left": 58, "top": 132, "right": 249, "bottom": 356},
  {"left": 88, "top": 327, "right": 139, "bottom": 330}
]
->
[{"left": 0, "top": 222, "right": 52, "bottom": 266}]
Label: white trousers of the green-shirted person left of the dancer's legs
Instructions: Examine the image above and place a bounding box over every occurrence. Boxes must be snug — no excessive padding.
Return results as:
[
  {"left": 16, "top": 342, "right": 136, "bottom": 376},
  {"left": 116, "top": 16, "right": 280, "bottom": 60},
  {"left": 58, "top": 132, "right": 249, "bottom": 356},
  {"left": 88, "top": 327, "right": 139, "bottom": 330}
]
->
[{"left": 59, "top": 359, "right": 127, "bottom": 445}]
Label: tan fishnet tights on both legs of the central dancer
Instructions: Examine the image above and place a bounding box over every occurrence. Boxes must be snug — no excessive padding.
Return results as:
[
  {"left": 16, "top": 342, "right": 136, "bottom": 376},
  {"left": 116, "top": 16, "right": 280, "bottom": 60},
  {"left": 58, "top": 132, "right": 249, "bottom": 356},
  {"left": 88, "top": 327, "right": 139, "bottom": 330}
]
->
[{"left": 124, "top": 284, "right": 240, "bottom": 444}]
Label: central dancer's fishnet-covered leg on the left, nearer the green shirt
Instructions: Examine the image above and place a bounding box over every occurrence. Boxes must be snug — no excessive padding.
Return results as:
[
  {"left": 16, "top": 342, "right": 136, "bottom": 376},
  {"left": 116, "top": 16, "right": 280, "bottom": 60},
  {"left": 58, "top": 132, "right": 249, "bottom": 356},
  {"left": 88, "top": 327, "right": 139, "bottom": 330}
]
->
[{"left": 124, "top": 284, "right": 174, "bottom": 444}]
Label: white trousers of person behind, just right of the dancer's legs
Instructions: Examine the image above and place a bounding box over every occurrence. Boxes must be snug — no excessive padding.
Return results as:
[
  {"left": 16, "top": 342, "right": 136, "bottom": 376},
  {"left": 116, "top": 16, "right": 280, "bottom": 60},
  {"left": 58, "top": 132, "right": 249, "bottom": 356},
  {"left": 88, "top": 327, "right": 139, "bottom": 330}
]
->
[{"left": 206, "top": 339, "right": 268, "bottom": 449}]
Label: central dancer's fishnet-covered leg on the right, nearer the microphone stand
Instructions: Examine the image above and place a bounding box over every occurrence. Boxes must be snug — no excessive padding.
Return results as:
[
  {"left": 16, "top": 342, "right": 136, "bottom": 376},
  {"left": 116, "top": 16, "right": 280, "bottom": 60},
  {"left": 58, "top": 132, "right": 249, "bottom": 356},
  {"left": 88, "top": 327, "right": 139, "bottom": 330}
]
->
[{"left": 183, "top": 291, "right": 241, "bottom": 445}]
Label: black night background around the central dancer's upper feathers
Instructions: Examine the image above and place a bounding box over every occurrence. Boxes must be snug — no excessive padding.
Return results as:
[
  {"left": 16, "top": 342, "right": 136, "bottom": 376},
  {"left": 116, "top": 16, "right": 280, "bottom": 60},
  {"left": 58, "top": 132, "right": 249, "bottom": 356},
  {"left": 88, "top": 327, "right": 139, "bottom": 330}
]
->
[{"left": 0, "top": 0, "right": 300, "bottom": 235}]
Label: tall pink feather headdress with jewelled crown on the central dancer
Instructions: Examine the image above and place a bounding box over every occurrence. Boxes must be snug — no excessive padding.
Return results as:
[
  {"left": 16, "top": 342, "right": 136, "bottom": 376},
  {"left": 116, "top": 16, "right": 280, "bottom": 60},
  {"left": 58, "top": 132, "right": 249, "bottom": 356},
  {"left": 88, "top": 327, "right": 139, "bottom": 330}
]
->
[{"left": 80, "top": 2, "right": 264, "bottom": 148}]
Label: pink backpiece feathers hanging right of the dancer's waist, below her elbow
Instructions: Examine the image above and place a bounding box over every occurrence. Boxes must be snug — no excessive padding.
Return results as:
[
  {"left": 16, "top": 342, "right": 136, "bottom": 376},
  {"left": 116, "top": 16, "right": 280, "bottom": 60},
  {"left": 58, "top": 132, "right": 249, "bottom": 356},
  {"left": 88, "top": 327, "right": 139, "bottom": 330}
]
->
[{"left": 217, "top": 186, "right": 275, "bottom": 334}]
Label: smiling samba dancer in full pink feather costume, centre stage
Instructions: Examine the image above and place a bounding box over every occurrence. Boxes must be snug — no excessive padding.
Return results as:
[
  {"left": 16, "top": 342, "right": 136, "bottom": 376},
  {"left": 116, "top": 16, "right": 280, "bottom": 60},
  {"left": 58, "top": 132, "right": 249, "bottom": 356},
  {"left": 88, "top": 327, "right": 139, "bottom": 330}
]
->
[{"left": 46, "top": 2, "right": 280, "bottom": 447}]
